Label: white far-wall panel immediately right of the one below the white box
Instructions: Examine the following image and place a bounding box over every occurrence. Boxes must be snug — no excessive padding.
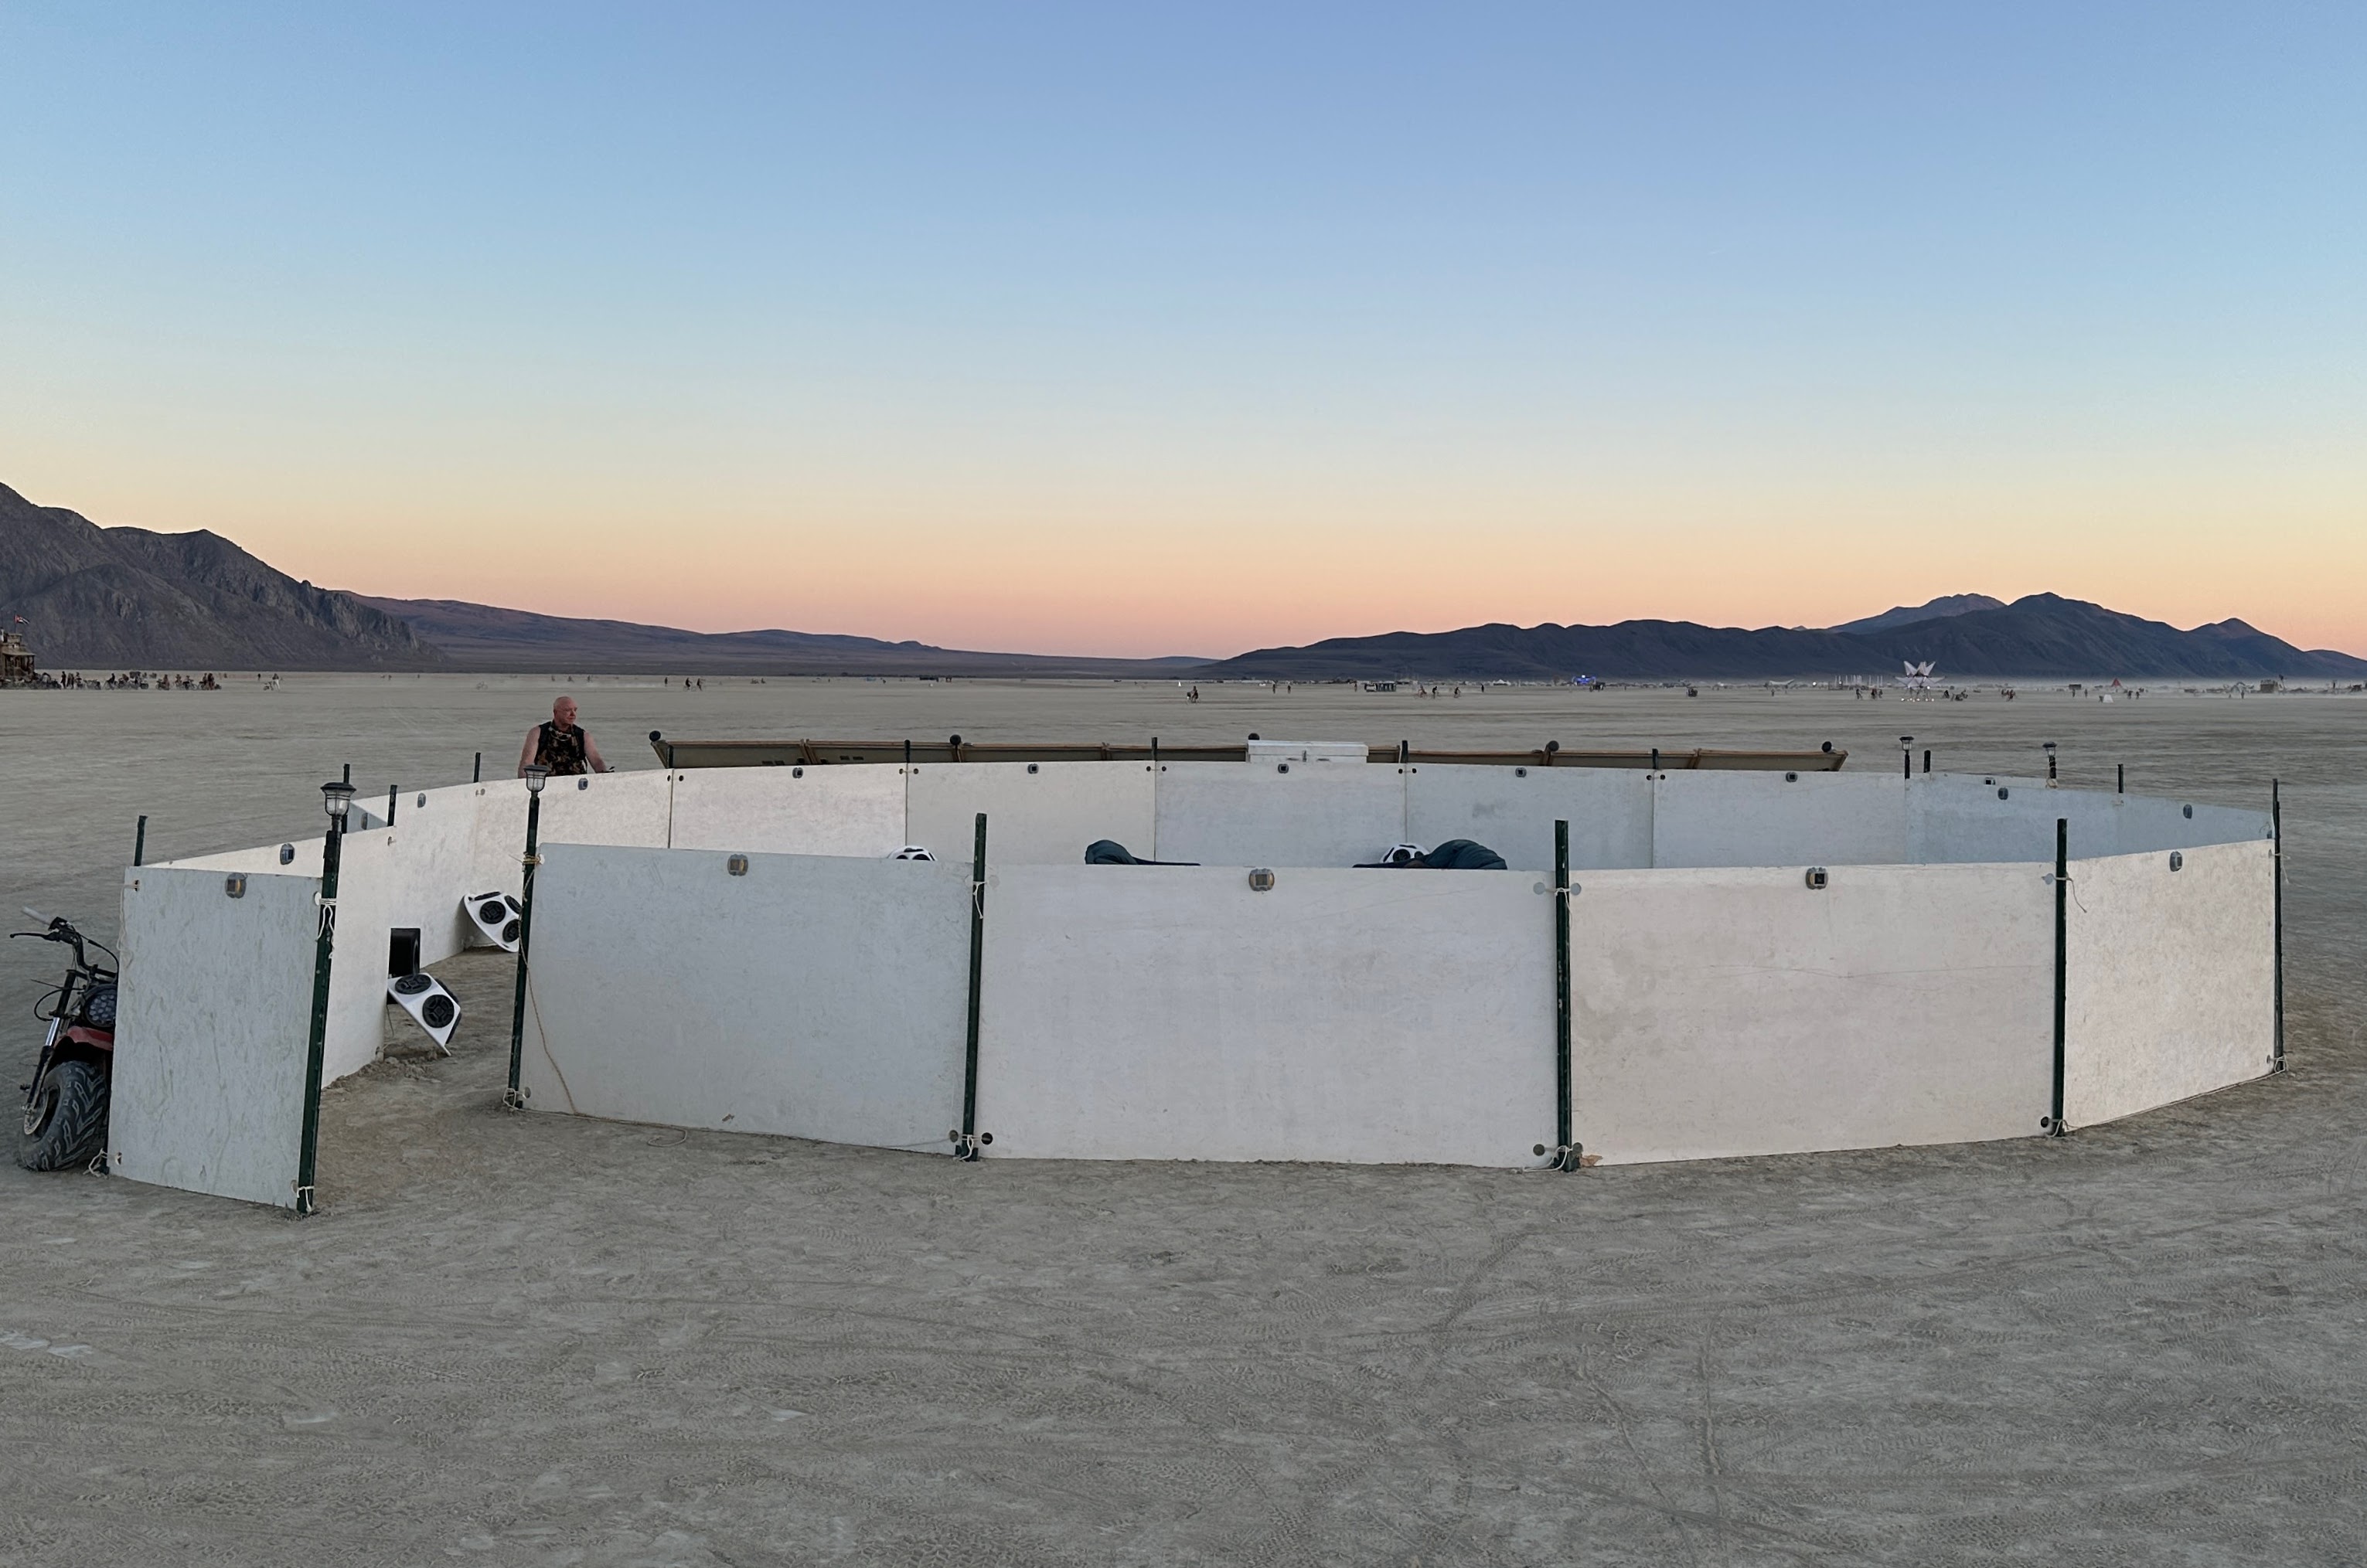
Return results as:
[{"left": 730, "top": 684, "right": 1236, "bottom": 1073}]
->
[{"left": 1406, "top": 764, "right": 1652, "bottom": 872}]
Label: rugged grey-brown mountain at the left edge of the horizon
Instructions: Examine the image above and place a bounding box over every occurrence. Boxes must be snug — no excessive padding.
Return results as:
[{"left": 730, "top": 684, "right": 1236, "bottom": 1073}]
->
[{"left": 0, "top": 485, "right": 445, "bottom": 672}]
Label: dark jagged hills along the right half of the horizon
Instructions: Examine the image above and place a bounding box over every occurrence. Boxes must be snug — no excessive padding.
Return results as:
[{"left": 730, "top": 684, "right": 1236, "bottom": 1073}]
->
[{"left": 1197, "top": 594, "right": 2367, "bottom": 681}]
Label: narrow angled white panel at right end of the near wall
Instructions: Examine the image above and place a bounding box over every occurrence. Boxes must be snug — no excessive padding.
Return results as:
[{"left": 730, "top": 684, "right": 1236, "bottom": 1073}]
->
[{"left": 2064, "top": 846, "right": 2277, "bottom": 1128}]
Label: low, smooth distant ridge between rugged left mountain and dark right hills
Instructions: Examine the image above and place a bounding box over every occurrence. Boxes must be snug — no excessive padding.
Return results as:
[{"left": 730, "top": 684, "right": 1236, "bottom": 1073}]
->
[{"left": 362, "top": 598, "right": 1207, "bottom": 676}]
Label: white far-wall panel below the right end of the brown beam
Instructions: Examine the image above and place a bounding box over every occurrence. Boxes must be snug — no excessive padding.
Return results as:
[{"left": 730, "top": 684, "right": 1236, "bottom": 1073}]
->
[{"left": 1652, "top": 771, "right": 1908, "bottom": 868}]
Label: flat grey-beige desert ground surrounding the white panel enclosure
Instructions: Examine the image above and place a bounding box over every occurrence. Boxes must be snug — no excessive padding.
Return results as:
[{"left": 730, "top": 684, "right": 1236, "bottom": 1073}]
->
[{"left": 0, "top": 676, "right": 2367, "bottom": 1563}]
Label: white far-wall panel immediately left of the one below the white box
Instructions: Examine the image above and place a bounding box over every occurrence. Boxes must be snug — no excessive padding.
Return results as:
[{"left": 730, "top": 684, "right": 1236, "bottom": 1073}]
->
[{"left": 907, "top": 761, "right": 1150, "bottom": 866}]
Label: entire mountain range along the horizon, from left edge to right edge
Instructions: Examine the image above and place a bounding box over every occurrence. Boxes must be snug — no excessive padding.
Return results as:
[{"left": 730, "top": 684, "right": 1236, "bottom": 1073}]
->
[{"left": 0, "top": 485, "right": 2367, "bottom": 681}]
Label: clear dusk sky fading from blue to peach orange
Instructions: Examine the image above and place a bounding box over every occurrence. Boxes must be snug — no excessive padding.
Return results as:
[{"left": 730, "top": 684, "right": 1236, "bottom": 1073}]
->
[{"left": 0, "top": 0, "right": 2367, "bottom": 655}]
